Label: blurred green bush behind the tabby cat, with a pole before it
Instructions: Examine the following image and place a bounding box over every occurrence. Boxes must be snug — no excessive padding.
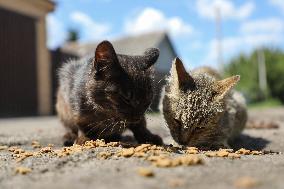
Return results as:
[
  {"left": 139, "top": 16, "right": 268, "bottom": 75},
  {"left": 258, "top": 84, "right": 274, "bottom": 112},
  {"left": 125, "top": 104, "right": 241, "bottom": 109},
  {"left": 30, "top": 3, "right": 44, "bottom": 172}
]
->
[{"left": 224, "top": 48, "right": 284, "bottom": 103}]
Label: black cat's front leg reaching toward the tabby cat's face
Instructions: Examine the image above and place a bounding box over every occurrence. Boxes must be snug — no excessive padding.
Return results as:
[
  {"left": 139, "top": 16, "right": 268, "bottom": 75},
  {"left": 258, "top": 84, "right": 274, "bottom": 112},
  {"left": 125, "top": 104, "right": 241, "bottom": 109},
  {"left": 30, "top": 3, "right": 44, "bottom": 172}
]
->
[{"left": 128, "top": 117, "right": 163, "bottom": 145}]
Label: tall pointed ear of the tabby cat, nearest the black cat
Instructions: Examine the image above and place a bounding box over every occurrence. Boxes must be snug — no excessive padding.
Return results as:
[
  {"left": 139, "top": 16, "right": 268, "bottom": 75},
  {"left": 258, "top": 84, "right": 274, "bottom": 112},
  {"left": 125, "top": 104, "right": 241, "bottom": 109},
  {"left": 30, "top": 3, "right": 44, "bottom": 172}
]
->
[{"left": 171, "top": 57, "right": 196, "bottom": 91}]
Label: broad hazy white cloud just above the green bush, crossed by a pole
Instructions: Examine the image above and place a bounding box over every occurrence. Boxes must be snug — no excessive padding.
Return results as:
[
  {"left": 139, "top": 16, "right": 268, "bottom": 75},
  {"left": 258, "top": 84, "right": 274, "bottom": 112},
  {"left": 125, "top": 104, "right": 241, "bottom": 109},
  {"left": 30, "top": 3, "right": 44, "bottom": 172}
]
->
[{"left": 202, "top": 17, "right": 284, "bottom": 66}]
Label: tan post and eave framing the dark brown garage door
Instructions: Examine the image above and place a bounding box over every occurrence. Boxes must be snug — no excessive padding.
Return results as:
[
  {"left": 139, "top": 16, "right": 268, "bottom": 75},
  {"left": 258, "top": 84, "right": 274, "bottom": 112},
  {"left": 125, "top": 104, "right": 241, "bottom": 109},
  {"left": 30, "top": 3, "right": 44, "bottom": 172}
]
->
[{"left": 0, "top": 0, "right": 54, "bottom": 115}]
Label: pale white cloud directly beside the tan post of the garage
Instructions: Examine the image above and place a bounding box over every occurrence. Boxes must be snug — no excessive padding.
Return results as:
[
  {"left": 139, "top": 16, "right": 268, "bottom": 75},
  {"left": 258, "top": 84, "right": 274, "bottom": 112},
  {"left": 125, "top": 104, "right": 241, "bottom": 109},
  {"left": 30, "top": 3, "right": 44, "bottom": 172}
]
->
[{"left": 46, "top": 14, "right": 67, "bottom": 49}]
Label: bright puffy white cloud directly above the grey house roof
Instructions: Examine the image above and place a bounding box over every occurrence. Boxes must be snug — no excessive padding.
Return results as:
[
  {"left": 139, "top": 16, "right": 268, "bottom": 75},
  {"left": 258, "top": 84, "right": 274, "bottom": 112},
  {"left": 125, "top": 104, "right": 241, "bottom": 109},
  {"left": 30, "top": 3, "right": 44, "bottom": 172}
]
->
[{"left": 125, "top": 7, "right": 193, "bottom": 36}]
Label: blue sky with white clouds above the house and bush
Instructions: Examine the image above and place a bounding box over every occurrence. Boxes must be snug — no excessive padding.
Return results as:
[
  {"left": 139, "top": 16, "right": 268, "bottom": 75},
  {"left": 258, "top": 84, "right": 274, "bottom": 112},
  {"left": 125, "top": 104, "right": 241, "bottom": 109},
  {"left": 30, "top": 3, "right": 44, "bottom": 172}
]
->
[{"left": 47, "top": 0, "right": 284, "bottom": 68}]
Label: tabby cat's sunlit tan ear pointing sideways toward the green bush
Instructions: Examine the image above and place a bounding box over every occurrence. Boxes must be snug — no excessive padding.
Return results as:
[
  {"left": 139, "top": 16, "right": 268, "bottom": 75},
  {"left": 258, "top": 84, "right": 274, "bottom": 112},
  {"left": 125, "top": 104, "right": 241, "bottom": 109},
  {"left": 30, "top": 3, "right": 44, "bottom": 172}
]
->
[{"left": 213, "top": 75, "right": 240, "bottom": 100}]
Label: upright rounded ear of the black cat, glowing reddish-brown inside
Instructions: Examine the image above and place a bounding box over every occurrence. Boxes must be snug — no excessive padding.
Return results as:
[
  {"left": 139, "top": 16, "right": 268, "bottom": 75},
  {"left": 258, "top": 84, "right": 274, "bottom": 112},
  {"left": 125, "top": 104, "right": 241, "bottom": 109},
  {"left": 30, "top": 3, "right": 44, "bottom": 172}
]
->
[{"left": 95, "top": 41, "right": 117, "bottom": 63}]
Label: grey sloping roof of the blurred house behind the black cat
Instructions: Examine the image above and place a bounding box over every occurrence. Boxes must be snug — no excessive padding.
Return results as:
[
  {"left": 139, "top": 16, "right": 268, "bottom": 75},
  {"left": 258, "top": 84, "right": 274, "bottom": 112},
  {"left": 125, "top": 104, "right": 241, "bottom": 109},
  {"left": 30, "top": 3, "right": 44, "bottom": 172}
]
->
[{"left": 61, "top": 32, "right": 175, "bottom": 57}]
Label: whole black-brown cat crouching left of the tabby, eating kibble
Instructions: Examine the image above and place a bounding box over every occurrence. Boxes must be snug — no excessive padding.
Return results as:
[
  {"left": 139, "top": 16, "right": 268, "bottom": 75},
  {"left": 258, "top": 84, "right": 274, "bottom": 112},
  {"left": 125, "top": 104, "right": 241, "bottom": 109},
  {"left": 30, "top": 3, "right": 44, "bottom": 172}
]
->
[{"left": 56, "top": 41, "right": 162, "bottom": 145}]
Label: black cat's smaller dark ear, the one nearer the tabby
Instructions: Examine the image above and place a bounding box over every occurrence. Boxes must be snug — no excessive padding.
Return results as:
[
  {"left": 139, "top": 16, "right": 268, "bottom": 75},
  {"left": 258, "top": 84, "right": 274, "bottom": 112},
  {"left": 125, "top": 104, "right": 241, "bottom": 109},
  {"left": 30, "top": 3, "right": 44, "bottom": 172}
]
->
[{"left": 142, "top": 48, "right": 160, "bottom": 70}]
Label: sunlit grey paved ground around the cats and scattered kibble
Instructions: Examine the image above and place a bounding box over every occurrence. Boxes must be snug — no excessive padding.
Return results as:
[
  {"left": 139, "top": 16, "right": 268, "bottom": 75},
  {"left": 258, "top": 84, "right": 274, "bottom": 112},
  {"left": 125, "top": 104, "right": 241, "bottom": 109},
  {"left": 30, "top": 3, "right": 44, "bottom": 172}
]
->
[{"left": 0, "top": 108, "right": 284, "bottom": 189}]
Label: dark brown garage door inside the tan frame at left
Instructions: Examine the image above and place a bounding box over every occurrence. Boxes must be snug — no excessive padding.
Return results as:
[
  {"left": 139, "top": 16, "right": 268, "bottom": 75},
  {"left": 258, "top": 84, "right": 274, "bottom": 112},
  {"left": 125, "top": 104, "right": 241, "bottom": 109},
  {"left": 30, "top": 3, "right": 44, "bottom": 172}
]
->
[{"left": 0, "top": 8, "right": 38, "bottom": 117}]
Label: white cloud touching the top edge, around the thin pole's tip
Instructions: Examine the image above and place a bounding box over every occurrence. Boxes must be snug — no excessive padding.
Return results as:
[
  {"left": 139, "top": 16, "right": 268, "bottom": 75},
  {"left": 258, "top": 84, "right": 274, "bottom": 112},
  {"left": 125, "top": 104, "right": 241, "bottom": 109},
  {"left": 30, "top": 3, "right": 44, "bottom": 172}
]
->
[{"left": 196, "top": 0, "right": 255, "bottom": 20}]
